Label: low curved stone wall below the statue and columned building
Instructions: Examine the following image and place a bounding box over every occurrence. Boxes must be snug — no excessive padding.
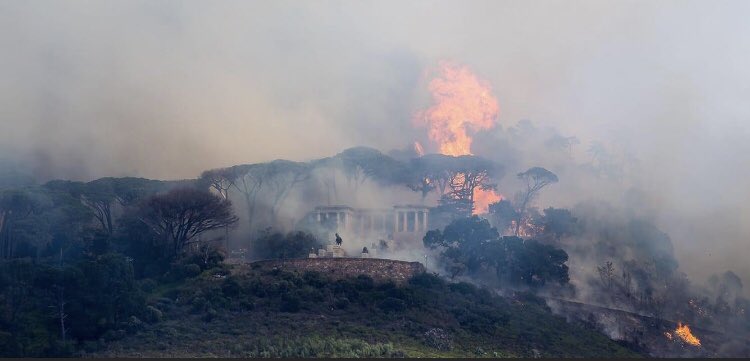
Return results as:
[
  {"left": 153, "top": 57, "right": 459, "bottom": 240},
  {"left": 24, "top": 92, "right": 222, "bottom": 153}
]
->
[{"left": 250, "top": 258, "right": 425, "bottom": 284}]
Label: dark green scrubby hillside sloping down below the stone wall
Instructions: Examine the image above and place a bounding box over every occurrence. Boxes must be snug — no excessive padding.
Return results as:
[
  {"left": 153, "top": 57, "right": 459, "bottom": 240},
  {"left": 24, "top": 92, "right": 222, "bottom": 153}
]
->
[{"left": 95, "top": 267, "right": 638, "bottom": 357}]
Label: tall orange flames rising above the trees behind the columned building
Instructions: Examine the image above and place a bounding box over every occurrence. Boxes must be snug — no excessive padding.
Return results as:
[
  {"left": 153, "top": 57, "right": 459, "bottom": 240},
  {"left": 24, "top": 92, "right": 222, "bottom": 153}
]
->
[{"left": 414, "top": 61, "right": 502, "bottom": 214}]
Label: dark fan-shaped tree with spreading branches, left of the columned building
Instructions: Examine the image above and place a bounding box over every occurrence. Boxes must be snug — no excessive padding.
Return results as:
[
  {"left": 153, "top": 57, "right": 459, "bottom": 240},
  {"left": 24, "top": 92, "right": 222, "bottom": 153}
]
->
[{"left": 139, "top": 188, "right": 237, "bottom": 256}]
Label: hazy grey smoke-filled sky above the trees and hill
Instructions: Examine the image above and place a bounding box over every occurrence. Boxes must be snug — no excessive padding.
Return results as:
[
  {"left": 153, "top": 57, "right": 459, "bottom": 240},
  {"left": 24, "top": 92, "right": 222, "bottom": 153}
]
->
[{"left": 0, "top": 0, "right": 750, "bottom": 279}]
